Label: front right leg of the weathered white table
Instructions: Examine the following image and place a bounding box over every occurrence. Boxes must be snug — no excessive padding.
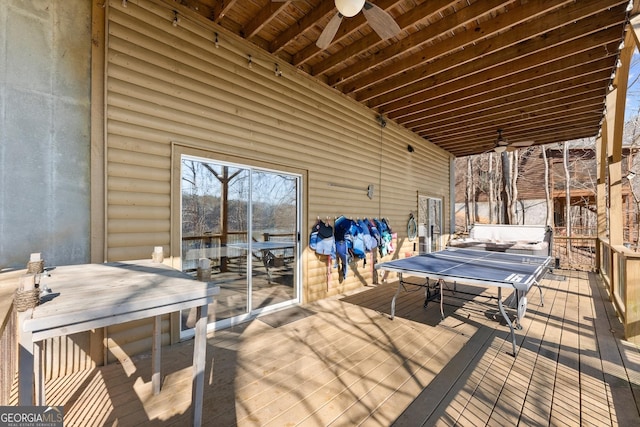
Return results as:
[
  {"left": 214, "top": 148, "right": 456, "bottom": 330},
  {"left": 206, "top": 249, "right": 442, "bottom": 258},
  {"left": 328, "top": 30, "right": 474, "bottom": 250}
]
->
[{"left": 191, "top": 305, "right": 208, "bottom": 426}]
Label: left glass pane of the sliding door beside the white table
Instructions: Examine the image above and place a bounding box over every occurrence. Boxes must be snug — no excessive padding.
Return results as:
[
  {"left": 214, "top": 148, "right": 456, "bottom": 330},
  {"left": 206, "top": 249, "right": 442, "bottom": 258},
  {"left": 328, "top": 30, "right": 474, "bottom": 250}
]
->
[{"left": 181, "top": 158, "right": 250, "bottom": 329}]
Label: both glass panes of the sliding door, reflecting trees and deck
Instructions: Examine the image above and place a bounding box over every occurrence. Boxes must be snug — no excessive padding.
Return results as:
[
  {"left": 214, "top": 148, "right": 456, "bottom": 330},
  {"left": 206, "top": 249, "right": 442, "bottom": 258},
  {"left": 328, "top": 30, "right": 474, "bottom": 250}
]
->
[{"left": 181, "top": 156, "right": 300, "bottom": 330}]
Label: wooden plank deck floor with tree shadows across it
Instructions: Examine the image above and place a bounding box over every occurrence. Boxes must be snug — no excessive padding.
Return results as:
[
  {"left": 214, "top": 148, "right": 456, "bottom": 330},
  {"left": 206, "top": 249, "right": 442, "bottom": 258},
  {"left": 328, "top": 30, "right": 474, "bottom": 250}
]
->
[{"left": 10, "top": 271, "right": 640, "bottom": 427}]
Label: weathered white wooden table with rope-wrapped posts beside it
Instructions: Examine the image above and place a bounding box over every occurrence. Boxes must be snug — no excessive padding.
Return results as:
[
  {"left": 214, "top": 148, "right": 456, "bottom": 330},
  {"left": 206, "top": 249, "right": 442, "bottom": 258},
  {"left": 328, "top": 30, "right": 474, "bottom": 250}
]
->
[{"left": 19, "top": 260, "right": 220, "bottom": 425}]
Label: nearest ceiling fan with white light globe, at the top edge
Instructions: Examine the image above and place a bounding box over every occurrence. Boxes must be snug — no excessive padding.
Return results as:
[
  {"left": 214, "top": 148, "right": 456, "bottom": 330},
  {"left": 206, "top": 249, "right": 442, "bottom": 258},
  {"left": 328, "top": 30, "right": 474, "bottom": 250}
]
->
[{"left": 273, "top": 0, "right": 401, "bottom": 49}]
